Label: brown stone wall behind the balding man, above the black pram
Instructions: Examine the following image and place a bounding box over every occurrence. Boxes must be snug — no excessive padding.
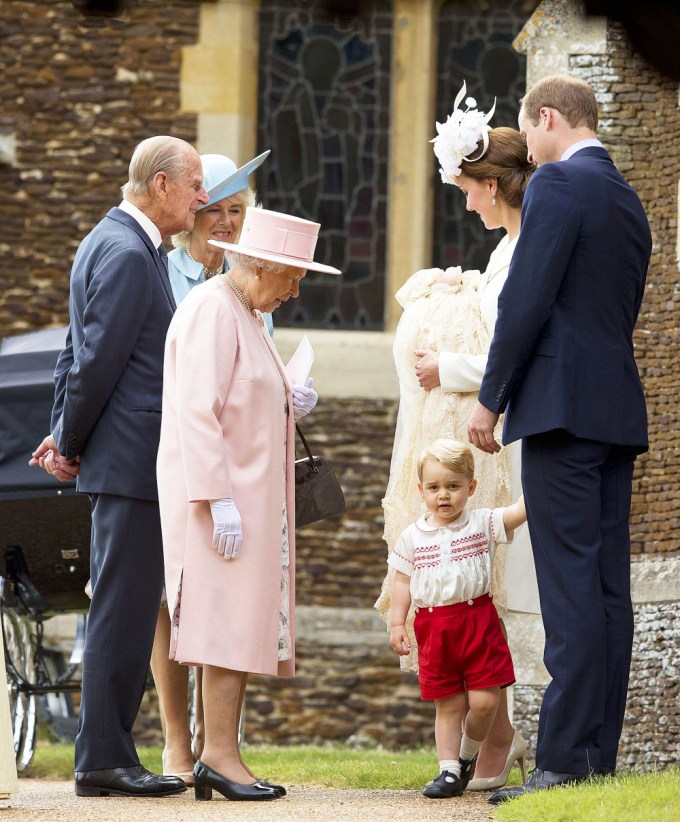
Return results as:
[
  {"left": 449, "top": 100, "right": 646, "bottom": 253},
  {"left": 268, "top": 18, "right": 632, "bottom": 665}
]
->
[{"left": 0, "top": 0, "right": 200, "bottom": 336}]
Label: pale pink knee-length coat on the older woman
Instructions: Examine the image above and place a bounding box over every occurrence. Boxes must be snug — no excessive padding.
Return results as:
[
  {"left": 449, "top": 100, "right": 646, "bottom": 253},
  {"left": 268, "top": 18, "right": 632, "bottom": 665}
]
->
[{"left": 158, "top": 277, "right": 295, "bottom": 676}]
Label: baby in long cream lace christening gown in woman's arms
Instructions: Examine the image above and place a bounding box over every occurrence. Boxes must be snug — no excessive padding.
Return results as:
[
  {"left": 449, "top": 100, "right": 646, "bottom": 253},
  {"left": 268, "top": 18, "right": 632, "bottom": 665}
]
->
[{"left": 375, "top": 267, "right": 511, "bottom": 671}]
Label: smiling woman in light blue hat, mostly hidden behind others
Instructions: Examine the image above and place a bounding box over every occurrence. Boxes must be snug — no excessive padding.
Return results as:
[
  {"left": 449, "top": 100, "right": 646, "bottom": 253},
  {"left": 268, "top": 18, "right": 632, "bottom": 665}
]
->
[{"left": 151, "top": 151, "right": 273, "bottom": 785}]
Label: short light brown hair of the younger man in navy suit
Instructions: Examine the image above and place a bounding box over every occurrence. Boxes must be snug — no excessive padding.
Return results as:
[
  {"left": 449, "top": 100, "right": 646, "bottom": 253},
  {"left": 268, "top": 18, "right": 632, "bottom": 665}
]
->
[{"left": 521, "top": 74, "right": 597, "bottom": 131}]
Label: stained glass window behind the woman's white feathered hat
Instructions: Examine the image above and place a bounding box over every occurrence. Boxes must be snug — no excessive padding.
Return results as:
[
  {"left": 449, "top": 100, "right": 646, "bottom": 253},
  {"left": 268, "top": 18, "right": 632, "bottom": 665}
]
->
[{"left": 432, "top": 0, "right": 536, "bottom": 271}]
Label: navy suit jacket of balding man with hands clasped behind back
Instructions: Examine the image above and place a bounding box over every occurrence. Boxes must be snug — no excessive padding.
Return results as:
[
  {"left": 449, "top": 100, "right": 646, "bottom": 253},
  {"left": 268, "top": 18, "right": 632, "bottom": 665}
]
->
[{"left": 51, "top": 208, "right": 175, "bottom": 500}]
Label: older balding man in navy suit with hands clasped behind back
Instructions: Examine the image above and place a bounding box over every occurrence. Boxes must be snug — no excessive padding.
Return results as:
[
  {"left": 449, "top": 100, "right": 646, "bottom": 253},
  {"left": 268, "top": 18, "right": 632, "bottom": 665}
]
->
[{"left": 31, "top": 137, "right": 208, "bottom": 796}]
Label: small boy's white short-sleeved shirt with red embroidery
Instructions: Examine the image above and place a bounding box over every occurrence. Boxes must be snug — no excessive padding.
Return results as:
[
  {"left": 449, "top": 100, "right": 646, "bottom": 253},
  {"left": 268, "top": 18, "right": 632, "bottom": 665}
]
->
[{"left": 387, "top": 508, "right": 512, "bottom": 608}]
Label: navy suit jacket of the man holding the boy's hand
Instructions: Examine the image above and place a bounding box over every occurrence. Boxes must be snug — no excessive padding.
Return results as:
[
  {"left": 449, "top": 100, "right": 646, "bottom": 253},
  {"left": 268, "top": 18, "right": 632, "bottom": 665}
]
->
[{"left": 479, "top": 147, "right": 651, "bottom": 458}]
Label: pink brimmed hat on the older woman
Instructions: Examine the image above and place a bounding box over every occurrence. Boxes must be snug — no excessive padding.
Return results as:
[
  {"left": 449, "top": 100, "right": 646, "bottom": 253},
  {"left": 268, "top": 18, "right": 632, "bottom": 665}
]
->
[{"left": 208, "top": 206, "right": 341, "bottom": 274}]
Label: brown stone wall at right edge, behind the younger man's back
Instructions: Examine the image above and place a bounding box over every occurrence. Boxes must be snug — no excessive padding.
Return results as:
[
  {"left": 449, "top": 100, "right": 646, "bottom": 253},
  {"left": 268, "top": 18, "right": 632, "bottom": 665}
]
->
[{"left": 570, "top": 24, "right": 680, "bottom": 553}]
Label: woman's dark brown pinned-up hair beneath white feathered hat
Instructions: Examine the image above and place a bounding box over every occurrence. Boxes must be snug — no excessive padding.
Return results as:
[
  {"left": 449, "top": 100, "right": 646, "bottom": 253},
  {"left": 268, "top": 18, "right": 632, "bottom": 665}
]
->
[{"left": 460, "top": 126, "right": 536, "bottom": 208}]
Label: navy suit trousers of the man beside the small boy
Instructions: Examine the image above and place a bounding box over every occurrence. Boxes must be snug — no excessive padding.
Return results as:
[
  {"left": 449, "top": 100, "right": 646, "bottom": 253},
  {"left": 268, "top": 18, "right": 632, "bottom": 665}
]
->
[{"left": 522, "top": 430, "right": 636, "bottom": 774}]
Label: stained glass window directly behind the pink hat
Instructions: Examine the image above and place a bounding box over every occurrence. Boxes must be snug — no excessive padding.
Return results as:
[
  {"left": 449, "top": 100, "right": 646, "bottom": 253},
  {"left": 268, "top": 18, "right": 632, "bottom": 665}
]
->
[{"left": 256, "top": 0, "right": 392, "bottom": 329}]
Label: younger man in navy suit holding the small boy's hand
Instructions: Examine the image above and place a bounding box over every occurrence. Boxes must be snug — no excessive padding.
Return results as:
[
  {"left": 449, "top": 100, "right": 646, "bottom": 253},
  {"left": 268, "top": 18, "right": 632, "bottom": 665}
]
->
[{"left": 468, "top": 76, "right": 651, "bottom": 804}]
